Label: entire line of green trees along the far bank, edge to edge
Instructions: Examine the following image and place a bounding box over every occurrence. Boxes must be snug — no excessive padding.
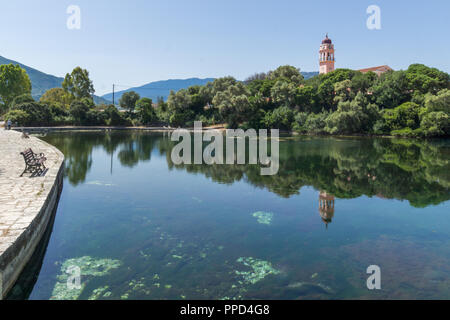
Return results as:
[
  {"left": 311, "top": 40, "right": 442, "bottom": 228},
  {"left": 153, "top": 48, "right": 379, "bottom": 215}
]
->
[{"left": 0, "top": 64, "right": 450, "bottom": 137}]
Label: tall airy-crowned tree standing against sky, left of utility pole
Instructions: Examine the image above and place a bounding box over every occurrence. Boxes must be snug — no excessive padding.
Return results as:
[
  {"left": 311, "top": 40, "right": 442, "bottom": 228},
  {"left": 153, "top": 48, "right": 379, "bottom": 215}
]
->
[{"left": 62, "top": 67, "right": 95, "bottom": 99}]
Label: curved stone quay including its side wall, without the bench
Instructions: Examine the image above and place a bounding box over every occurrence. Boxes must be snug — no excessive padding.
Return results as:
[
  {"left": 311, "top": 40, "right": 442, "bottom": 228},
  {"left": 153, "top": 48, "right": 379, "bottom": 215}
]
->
[{"left": 0, "top": 130, "right": 64, "bottom": 300}]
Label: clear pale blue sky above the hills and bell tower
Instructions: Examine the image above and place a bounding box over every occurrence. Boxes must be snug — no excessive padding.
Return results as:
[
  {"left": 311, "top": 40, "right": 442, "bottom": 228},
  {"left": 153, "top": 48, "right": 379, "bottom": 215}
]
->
[{"left": 0, "top": 0, "right": 450, "bottom": 95}]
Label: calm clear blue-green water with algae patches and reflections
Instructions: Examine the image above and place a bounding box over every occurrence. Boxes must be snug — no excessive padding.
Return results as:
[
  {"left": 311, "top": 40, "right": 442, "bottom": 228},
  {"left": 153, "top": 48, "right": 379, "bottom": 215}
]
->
[{"left": 10, "top": 132, "right": 450, "bottom": 299}]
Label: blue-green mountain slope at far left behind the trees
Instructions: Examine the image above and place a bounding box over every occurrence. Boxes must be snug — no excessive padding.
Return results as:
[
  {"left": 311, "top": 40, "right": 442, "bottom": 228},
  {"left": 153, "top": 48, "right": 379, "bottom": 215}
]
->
[{"left": 0, "top": 56, "right": 110, "bottom": 104}]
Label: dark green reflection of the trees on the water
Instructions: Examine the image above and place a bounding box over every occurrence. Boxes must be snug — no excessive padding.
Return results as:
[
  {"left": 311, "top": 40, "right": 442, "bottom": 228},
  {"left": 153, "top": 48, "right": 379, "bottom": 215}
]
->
[{"left": 45, "top": 132, "right": 450, "bottom": 207}]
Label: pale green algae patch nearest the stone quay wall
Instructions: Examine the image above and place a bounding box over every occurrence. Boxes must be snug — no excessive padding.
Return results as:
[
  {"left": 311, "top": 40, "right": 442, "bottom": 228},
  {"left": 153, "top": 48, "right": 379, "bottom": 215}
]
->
[{"left": 50, "top": 256, "right": 121, "bottom": 300}]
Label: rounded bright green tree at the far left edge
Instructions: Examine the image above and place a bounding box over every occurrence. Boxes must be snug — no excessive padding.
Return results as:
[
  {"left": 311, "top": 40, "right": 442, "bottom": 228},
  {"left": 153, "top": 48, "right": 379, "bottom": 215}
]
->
[{"left": 0, "top": 63, "right": 31, "bottom": 108}]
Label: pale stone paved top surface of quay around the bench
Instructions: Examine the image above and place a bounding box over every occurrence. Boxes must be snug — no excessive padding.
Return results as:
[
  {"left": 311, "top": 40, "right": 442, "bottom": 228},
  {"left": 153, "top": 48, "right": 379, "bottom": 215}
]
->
[{"left": 0, "top": 128, "right": 64, "bottom": 257}]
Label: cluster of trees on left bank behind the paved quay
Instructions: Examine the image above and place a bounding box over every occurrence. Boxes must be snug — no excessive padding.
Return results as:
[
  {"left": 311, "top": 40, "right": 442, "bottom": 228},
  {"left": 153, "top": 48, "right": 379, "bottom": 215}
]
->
[{"left": 0, "top": 64, "right": 132, "bottom": 126}]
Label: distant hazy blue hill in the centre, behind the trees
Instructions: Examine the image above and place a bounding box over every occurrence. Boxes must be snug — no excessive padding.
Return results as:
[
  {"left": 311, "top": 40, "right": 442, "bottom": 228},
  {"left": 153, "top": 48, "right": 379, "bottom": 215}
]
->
[{"left": 102, "top": 78, "right": 214, "bottom": 103}]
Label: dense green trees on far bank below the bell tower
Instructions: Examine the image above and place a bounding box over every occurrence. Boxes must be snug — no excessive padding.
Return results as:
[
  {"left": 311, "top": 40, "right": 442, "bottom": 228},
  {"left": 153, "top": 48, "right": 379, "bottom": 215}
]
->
[{"left": 115, "top": 64, "right": 450, "bottom": 137}]
